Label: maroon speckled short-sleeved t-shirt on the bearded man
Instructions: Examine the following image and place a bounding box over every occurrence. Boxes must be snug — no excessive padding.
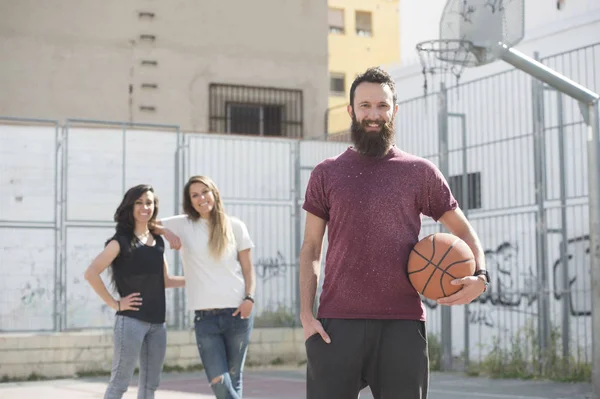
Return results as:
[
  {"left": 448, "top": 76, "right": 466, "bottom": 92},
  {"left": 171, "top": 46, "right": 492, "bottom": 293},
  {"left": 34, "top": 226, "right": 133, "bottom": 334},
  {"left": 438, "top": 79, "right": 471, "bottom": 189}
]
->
[{"left": 302, "top": 147, "right": 457, "bottom": 320}]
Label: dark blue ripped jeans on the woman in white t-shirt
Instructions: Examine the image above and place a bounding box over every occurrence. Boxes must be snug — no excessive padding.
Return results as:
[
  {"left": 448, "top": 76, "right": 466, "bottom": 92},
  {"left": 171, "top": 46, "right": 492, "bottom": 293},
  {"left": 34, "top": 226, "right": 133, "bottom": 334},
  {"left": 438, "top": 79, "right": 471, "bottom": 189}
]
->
[{"left": 194, "top": 308, "right": 254, "bottom": 399}]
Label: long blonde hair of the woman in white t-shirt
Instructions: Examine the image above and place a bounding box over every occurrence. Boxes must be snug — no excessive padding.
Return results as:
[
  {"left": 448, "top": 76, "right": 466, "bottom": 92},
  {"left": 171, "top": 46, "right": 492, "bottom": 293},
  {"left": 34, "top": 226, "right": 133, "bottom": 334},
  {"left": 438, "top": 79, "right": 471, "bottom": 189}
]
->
[{"left": 183, "top": 176, "right": 233, "bottom": 259}]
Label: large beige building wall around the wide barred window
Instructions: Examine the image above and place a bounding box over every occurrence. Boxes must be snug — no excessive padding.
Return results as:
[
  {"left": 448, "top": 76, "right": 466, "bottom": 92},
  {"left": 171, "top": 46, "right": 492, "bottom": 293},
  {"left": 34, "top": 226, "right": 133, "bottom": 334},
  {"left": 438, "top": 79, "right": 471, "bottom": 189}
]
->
[{"left": 0, "top": 0, "right": 328, "bottom": 137}]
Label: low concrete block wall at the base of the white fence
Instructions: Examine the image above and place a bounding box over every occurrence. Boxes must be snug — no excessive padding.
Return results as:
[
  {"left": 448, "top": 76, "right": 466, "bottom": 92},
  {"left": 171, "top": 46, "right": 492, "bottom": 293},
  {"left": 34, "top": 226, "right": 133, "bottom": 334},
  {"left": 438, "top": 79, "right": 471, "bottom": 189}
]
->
[{"left": 0, "top": 328, "right": 306, "bottom": 378}]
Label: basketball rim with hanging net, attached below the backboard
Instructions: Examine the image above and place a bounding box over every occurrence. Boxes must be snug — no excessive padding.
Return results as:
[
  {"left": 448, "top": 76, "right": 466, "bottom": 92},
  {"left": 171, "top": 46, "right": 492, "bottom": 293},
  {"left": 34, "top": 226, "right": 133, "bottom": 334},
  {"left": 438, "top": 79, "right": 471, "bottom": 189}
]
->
[{"left": 417, "top": 39, "right": 474, "bottom": 96}]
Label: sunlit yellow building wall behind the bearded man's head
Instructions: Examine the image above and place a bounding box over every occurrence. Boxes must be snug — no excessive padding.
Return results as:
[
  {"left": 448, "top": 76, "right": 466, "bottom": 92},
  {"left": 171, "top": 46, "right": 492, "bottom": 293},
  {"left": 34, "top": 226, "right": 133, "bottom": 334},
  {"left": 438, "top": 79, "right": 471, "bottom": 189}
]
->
[{"left": 328, "top": 0, "right": 400, "bottom": 133}]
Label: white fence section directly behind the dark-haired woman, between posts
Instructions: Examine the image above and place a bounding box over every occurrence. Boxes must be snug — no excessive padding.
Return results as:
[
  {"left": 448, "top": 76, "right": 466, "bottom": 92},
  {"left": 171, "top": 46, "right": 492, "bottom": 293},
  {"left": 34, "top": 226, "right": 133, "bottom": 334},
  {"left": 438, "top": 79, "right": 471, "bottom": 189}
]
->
[{"left": 61, "top": 120, "right": 181, "bottom": 329}]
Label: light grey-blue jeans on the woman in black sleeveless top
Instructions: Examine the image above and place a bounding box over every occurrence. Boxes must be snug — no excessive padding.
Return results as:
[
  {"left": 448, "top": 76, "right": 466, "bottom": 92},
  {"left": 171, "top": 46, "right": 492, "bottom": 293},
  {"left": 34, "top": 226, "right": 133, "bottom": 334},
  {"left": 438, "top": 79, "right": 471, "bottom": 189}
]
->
[{"left": 104, "top": 315, "right": 167, "bottom": 399}]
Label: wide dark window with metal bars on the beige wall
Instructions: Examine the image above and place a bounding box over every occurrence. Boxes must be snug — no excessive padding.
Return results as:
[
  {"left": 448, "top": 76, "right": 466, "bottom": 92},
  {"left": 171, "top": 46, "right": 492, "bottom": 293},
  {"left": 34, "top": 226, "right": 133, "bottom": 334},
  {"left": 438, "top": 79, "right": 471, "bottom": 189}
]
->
[{"left": 209, "top": 83, "right": 303, "bottom": 138}]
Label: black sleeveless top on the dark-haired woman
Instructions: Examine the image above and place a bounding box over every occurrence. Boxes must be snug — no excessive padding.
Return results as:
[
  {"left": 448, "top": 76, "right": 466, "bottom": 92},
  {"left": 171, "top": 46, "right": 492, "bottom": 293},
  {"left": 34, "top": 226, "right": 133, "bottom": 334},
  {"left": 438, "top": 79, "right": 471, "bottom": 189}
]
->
[{"left": 112, "top": 234, "right": 165, "bottom": 324}]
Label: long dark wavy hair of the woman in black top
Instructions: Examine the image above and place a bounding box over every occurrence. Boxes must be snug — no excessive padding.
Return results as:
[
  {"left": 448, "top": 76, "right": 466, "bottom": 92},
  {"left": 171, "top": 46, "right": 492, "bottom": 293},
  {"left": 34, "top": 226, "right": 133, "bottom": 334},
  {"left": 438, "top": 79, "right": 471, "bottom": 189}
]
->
[{"left": 104, "top": 184, "right": 158, "bottom": 287}]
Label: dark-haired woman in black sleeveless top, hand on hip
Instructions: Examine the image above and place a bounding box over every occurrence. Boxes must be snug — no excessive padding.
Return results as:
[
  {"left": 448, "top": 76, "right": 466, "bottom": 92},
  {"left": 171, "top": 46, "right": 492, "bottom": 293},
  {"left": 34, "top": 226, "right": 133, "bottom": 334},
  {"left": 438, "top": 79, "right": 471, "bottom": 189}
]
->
[{"left": 85, "top": 184, "right": 185, "bottom": 399}]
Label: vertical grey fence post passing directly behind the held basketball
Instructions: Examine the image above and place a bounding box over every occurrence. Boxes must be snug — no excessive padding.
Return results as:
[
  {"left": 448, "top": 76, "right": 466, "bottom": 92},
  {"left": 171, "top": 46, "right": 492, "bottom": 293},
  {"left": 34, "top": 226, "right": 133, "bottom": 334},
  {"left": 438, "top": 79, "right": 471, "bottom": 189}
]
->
[{"left": 438, "top": 83, "right": 452, "bottom": 370}]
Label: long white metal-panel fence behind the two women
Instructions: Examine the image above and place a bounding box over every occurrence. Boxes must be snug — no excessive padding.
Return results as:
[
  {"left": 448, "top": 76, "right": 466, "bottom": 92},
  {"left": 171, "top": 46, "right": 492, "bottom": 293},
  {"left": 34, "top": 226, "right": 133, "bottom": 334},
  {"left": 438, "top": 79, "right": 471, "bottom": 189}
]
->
[{"left": 0, "top": 118, "right": 347, "bottom": 332}]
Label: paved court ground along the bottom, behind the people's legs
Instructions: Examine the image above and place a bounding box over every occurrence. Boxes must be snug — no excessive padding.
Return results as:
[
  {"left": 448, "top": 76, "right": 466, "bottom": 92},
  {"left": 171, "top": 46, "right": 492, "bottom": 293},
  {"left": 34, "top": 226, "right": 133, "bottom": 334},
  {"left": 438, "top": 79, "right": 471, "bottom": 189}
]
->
[{"left": 0, "top": 367, "right": 593, "bottom": 399}]
